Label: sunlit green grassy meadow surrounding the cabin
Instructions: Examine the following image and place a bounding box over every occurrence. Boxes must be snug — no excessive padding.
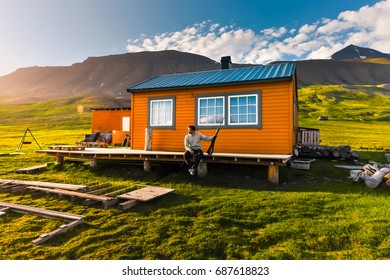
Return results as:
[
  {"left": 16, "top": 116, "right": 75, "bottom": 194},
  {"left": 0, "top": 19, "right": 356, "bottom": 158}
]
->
[{"left": 0, "top": 86, "right": 390, "bottom": 260}]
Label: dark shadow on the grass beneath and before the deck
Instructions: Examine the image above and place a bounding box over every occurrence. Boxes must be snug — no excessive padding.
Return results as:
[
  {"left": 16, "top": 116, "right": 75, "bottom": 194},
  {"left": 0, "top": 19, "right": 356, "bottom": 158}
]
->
[{"left": 45, "top": 154, "right": 390, "bottom": 196}]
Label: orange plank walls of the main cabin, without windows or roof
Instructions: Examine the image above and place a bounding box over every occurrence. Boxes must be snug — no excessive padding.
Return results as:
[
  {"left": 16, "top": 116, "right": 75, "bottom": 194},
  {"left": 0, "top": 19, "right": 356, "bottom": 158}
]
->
[{"left": 131, "top": 80, "right": 298, "bottom": 154}]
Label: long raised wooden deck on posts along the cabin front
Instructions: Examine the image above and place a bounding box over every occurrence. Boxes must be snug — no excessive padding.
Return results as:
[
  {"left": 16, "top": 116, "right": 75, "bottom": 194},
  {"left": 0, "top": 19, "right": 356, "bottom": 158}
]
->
[{"left": 37, "top": 148, "right": 292, "bottom": 183}]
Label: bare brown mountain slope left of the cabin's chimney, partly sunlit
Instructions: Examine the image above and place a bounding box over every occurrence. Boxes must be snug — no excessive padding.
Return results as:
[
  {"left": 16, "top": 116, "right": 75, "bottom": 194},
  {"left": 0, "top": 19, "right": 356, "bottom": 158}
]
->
[{"left": 0, "top": 51, "right": 225, "bottom": 103}]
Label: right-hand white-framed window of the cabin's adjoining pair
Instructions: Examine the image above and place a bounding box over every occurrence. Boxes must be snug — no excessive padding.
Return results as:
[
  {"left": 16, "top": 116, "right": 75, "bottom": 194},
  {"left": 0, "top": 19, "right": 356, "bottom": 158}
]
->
[{"left": 229, "top": 94, "right": 258, "bottom": 125}]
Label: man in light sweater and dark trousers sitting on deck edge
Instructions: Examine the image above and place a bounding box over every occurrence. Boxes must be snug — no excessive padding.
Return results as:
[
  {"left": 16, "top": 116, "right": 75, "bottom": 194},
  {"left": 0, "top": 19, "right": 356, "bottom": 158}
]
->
[{"left": 184, "top": 125, "right": 214, "bottom": 175}]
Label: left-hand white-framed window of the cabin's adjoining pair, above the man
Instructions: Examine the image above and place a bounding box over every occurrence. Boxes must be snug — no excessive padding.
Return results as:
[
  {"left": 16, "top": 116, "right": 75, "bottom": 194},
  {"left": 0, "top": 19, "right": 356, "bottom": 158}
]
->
[{"left": 198, "top": 97, "right": 225, "bottom": 126}]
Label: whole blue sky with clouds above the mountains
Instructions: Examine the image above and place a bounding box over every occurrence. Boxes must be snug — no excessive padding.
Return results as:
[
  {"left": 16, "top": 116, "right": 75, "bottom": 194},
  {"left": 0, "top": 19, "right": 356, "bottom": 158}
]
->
[{"left": 0, "top": 0, "right": 390, "bottom": 75}]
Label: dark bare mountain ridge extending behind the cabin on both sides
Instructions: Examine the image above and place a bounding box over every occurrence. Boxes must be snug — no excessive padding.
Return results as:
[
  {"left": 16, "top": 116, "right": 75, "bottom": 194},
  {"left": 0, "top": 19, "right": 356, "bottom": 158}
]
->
[{"left": 0, "top": 47, "right": 390, "bottom": 107}]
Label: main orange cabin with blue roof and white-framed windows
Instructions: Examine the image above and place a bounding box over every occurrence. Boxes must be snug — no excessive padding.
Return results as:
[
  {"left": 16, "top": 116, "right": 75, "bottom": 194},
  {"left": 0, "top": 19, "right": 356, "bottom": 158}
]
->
[{"left": 127, "top": 62, "right": 298, "bottom": 155}]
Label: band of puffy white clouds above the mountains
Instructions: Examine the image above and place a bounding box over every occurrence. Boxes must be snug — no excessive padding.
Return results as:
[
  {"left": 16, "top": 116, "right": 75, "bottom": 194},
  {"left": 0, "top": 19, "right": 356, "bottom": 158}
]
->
[{"left": 127, "top": 0, "right": 390, "bottom": 64}]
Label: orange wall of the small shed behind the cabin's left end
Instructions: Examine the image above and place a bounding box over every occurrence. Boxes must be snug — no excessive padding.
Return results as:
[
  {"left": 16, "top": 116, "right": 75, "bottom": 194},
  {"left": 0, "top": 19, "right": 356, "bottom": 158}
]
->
[{"left": 92, "top": 109, "right": 131, "bottom": 132}]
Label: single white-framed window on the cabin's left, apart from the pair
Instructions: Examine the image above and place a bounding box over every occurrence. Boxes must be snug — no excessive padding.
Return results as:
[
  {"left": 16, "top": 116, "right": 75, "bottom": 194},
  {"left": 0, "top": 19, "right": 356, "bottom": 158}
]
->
[{"left": 149, "top": 98, "right": 174, "bottom": 127}]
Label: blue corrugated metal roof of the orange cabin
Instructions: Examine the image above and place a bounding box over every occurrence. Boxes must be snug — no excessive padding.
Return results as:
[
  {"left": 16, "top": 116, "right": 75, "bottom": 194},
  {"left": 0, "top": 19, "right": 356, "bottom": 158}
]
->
[{"left": 127, "top": 62, "right": 296, "bottom": 92}]
